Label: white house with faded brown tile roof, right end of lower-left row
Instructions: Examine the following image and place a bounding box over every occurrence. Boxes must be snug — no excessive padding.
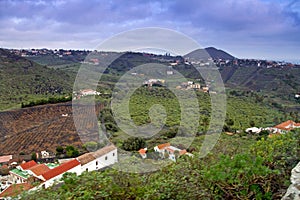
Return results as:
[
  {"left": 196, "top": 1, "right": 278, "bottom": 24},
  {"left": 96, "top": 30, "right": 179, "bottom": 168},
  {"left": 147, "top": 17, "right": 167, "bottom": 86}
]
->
[{"left": 77, "top": 145, "right": 118, "bottom": 172}]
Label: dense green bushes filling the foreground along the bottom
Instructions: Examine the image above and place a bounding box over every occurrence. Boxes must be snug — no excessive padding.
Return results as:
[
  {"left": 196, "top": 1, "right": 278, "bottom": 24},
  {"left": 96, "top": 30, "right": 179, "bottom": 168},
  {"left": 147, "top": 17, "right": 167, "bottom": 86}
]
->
[{"left": 22, "top": 130, "right": 300, "bottom": 199}]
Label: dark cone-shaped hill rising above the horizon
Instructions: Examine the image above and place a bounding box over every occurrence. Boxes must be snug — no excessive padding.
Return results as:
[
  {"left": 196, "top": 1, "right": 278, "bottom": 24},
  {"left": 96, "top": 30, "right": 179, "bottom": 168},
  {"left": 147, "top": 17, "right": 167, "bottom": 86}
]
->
[{"left": 184, "top": 47, "right": 235, "bottom": 60}]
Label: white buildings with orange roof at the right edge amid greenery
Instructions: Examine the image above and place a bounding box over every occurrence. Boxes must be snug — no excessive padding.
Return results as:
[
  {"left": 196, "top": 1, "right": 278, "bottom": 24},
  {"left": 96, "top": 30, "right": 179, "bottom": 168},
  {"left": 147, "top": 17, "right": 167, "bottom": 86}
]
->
[{"left": 246, "top": 120, "right": 300, "bottom": 137}]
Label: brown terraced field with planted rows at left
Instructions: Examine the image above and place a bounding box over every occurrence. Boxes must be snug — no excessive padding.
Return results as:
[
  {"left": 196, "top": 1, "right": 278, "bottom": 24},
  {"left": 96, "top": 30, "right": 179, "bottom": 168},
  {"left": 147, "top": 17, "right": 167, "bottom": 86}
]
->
[{"left": 0, "top": 102, "right": 103, "bottom": 155}]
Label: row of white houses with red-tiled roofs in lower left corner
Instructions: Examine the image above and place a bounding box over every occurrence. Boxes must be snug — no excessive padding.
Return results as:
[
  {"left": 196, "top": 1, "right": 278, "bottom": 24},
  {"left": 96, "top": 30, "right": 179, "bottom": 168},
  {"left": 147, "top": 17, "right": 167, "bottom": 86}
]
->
[{"left": 0, "top": 145, "right": 118, "bottom": 199}]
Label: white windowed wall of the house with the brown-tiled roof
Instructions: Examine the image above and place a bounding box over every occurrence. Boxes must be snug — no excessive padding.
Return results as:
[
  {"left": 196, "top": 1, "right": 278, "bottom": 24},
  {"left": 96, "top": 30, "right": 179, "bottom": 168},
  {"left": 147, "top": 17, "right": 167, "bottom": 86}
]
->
[{"left": 81, "top": 149, "right": 118, "bottom": 172}]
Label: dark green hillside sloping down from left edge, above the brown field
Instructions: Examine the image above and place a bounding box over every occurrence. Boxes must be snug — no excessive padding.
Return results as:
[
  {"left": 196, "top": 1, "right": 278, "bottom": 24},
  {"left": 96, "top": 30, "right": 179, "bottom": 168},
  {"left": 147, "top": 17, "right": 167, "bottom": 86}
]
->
[{"left": 0, "top": 49, "right": 74, "bottom": 110}]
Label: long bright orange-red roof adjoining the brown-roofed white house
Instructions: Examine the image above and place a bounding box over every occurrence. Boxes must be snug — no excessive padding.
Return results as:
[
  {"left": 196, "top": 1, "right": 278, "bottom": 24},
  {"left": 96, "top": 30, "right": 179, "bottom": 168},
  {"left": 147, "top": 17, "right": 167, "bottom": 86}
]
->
[{"left": 42, "top": 159, "right": 80, "bottom": 180}]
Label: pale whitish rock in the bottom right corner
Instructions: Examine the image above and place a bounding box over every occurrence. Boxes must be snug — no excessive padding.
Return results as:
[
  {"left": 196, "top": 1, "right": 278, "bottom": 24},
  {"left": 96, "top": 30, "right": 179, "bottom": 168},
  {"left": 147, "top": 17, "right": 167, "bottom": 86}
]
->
[{"left": 282, "top": 162, "right": 300, "bottom": 200}]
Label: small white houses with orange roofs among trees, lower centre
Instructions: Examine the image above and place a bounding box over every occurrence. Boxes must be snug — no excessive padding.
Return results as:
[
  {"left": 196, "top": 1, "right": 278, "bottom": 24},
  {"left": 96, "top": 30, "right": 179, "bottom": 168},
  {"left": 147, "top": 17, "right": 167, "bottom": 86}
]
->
[{"left": 138, "top": 143, "right": 193, "bottom": 162}]
